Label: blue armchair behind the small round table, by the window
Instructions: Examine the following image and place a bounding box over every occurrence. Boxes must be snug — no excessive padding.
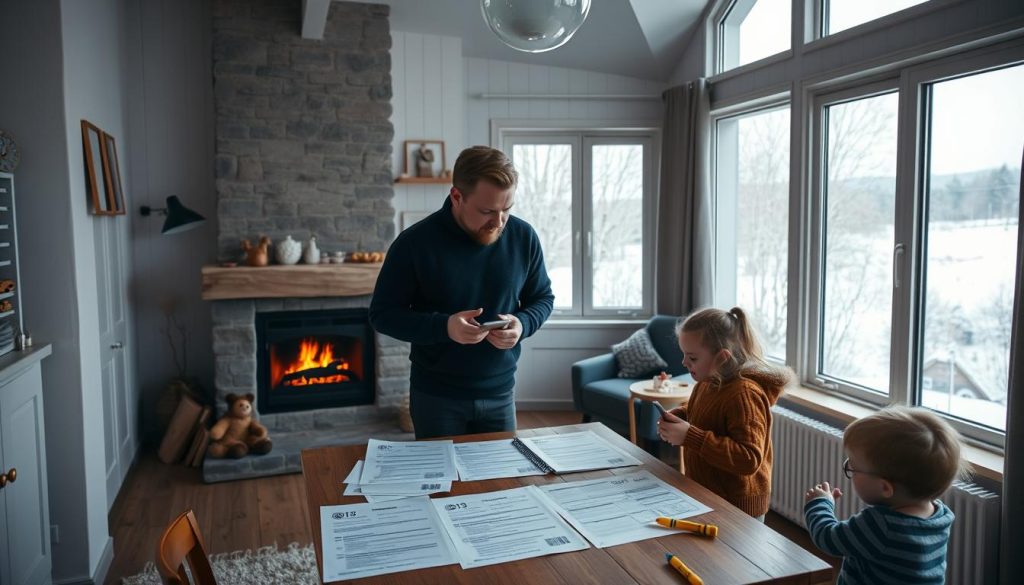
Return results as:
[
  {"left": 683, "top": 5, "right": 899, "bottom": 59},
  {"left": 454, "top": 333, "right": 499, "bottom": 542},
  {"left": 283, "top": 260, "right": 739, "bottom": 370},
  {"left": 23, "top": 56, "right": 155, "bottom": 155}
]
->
[{"left": 572, "top": 315, "right": 693, "bottom": 441}]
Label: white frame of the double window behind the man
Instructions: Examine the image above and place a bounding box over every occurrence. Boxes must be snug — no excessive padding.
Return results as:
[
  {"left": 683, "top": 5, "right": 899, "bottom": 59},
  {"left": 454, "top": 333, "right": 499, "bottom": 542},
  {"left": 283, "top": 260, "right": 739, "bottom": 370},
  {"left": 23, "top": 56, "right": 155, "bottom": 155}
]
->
[{"left": 490, "top": 120, "right": 660, "bottom": 320}]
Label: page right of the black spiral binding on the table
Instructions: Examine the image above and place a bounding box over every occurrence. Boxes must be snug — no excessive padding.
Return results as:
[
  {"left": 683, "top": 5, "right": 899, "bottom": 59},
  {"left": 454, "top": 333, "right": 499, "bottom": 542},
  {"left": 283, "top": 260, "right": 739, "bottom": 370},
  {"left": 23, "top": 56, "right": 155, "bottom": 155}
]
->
[{"left": 512, "top": 430, "right": 640, "bottom": 473}]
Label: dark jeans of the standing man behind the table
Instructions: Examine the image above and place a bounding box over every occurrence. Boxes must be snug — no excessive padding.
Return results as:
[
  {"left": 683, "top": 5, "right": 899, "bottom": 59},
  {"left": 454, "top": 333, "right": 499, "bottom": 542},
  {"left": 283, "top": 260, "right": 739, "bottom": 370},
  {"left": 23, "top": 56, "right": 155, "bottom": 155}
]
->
[{"left": 409, "top": 388, "right": 515, "bottom": 438}]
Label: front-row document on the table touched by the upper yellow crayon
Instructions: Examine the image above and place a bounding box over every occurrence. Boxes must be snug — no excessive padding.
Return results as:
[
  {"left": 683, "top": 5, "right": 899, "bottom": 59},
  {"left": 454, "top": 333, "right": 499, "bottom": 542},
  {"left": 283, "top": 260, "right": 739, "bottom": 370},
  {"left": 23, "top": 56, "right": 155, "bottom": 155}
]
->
[{"left": 539, "top": 470, "right": 711, "bottom": 548}]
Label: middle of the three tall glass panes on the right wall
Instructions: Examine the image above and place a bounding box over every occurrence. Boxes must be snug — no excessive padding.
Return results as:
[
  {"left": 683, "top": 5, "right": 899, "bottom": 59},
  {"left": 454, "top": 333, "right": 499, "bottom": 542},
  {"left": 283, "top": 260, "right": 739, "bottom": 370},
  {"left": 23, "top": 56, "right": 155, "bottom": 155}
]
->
[{"left": 814, "top": 91, "right": 899, "bottom": 395}]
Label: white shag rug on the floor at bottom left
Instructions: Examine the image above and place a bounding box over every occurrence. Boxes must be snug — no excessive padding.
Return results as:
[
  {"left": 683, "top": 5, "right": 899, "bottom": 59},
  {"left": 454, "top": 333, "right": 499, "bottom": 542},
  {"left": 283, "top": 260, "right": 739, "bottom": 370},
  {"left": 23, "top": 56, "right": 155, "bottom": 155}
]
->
[{"left": 121, "top": 542, "right": 321, "bottom": 585}]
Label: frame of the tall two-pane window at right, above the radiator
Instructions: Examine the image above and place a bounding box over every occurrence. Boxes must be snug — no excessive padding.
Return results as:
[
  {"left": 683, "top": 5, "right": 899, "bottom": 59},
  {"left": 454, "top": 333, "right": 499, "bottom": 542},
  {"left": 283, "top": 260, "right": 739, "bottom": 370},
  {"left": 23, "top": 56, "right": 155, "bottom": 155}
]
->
[{"left": 787, "top": 39, "right": 1024, "bottom": 452}]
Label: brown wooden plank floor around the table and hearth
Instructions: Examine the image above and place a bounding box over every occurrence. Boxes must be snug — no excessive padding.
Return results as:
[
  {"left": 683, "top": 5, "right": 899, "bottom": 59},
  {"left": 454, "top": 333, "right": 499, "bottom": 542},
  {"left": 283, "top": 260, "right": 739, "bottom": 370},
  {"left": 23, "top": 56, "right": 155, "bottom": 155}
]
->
[{"left": 106, "top": 411, "right": 838, "bottom": 584}]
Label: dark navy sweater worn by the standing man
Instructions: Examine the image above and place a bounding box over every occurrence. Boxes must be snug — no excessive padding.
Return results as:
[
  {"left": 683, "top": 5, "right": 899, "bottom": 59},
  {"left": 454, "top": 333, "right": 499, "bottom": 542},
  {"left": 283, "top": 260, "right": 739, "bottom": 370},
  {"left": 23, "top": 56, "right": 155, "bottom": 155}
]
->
[{"left": 370, "top": 199, "right": 555, "bottom": 399}]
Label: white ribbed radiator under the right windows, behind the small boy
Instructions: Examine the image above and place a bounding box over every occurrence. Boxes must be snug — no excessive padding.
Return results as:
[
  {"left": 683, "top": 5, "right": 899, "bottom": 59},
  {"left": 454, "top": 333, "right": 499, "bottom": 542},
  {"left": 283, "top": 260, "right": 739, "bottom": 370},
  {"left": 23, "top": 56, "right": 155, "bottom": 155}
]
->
[{"left": 771, "top": 407, "right": 999, "bottom": 585}]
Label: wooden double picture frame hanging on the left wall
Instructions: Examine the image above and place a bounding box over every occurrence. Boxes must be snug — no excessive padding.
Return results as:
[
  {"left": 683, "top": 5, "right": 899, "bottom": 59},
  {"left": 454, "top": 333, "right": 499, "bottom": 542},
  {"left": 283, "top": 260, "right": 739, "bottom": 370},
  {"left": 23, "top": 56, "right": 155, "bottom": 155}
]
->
[{"left": 82, "top": 120, "right": 125, "bottom": 215}]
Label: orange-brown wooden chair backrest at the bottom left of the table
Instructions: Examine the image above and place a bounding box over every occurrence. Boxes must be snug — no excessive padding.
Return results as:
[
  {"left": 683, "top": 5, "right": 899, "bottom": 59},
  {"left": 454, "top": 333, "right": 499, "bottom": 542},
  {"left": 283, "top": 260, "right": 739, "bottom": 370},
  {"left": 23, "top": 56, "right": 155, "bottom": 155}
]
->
[{"left": 157, "top": 510, "right": 217, "bottom": 585}]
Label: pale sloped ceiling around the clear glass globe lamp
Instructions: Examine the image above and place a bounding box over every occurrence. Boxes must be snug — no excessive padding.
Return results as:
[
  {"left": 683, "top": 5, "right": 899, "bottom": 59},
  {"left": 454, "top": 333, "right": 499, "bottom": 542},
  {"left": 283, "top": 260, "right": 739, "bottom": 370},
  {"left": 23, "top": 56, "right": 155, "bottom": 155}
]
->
[{"left": 364, "top": 0, "right": 708, "bottom": 81}]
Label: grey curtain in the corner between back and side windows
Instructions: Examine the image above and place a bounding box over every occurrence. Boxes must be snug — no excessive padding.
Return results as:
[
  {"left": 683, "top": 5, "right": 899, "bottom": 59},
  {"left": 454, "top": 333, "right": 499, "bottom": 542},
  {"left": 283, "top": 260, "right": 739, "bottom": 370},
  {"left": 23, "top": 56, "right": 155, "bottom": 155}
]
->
[{"left": 654, "top": 79, "right": 714, "bottom": 316}]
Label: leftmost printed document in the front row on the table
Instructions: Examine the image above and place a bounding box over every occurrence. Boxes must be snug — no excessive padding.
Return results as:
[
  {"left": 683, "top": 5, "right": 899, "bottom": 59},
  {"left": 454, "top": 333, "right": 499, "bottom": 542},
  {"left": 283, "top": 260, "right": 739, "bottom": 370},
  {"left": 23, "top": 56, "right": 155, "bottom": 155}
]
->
[{"left": 321, "top": 497, "right": 458, "bottom": 582}]
